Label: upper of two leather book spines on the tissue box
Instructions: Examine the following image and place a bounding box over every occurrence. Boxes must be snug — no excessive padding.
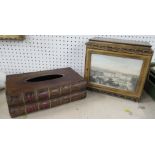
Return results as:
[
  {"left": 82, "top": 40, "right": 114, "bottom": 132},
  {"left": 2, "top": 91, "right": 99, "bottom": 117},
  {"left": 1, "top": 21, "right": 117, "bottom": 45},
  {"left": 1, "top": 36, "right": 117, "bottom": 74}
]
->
[{"left": 6, "top": 81, "right": 87, "bottom": 106}]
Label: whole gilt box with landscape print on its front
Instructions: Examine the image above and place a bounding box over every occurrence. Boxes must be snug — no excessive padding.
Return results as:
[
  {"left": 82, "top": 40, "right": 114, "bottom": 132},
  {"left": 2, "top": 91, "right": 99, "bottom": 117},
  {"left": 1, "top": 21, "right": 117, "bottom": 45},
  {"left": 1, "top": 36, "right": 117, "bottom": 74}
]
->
[{"left": 85, "top": 40, "right": 152, "bottom": 101}]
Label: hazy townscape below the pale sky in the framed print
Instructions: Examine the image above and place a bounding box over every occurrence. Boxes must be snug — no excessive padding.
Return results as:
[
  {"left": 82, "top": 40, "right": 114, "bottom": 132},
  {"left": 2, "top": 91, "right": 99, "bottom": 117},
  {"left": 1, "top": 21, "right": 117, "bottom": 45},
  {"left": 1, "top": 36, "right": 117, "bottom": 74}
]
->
[{"left": 90, "top": 68, "right": 138, "bottom": 91}]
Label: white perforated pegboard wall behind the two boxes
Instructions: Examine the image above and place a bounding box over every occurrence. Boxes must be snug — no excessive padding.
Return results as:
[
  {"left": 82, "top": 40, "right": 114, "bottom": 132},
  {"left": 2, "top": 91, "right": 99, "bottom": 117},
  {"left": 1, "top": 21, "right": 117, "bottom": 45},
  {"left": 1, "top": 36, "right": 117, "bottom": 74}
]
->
[{"left": 0, "top": 35, "right": 155, "bottom": 75}]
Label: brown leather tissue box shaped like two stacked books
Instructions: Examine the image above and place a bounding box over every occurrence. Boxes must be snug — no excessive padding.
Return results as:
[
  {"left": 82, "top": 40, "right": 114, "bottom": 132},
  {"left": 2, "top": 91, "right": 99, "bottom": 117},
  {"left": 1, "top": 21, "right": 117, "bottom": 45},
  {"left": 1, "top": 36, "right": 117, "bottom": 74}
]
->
[{"left": 6, "top": 68, "right": 87, "bottom": 117}]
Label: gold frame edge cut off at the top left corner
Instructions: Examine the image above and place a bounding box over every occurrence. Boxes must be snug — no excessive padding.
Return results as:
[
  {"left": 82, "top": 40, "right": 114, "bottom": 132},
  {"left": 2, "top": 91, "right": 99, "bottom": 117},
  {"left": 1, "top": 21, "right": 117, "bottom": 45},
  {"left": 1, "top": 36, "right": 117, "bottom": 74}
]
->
[{"left": 0, "top": 35, "right": 25, "bottom": 40}]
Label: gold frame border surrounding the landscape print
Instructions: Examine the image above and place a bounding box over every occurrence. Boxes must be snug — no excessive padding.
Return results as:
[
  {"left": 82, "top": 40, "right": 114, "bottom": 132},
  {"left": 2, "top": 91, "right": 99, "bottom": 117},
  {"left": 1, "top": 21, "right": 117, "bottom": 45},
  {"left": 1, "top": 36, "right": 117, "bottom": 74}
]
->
[{"left": 84, "top": 47, "right": 151, "bottom": 101}]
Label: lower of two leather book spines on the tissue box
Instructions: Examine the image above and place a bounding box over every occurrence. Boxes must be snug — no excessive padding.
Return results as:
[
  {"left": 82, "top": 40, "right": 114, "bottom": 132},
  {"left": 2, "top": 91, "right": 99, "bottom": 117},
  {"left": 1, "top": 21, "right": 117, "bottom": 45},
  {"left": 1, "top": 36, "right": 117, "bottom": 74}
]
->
[{"left": 9, "top": 91, "right": 87, "bottom": 118}]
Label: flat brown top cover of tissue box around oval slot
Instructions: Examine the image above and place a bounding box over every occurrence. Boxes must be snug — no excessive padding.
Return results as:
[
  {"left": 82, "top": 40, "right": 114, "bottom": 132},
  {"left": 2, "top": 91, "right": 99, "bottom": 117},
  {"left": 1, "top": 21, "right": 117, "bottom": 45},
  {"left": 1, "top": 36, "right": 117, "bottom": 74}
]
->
[{"left": 6, "top": 68, "right": 86, "bottom": 96}]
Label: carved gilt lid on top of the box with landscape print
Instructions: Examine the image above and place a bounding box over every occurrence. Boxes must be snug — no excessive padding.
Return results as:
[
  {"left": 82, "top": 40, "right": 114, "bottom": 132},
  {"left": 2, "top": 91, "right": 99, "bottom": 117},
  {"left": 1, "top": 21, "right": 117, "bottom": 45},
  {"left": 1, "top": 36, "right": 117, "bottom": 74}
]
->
[{"left": 86, "top": 37, "right": 153, "bottom": 56}]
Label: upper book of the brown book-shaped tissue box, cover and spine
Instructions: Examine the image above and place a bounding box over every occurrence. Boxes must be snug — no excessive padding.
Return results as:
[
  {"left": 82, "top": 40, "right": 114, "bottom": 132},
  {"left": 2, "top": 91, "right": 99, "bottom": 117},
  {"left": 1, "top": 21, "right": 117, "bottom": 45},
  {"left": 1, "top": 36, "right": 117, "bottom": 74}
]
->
[{"left": 6, "top": 68, "right": 87, "bottom": 106}]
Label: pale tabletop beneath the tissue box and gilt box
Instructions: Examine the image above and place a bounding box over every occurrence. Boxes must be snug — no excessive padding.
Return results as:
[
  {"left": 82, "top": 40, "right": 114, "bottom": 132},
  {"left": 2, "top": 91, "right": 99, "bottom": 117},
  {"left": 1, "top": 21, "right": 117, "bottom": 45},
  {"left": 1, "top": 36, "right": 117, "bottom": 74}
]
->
[{"left": 0, "top": 91, "right": 155, "bottom": 119}]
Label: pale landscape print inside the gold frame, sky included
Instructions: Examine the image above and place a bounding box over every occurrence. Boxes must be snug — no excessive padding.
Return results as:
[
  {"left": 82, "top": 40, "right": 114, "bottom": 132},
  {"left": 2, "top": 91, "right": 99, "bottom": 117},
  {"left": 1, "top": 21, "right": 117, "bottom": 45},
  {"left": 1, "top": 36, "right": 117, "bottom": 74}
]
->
[{"left": 90, "top": 54, "right": 143, "bottom": 91}]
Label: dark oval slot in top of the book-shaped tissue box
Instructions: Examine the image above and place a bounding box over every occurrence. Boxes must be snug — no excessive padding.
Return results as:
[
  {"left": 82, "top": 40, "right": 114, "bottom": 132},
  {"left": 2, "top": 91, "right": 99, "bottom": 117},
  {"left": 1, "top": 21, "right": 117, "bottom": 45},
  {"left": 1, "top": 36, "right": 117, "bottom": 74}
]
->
[{"left": 27, "top": 74, "right": 63, "bottom": 82}]
